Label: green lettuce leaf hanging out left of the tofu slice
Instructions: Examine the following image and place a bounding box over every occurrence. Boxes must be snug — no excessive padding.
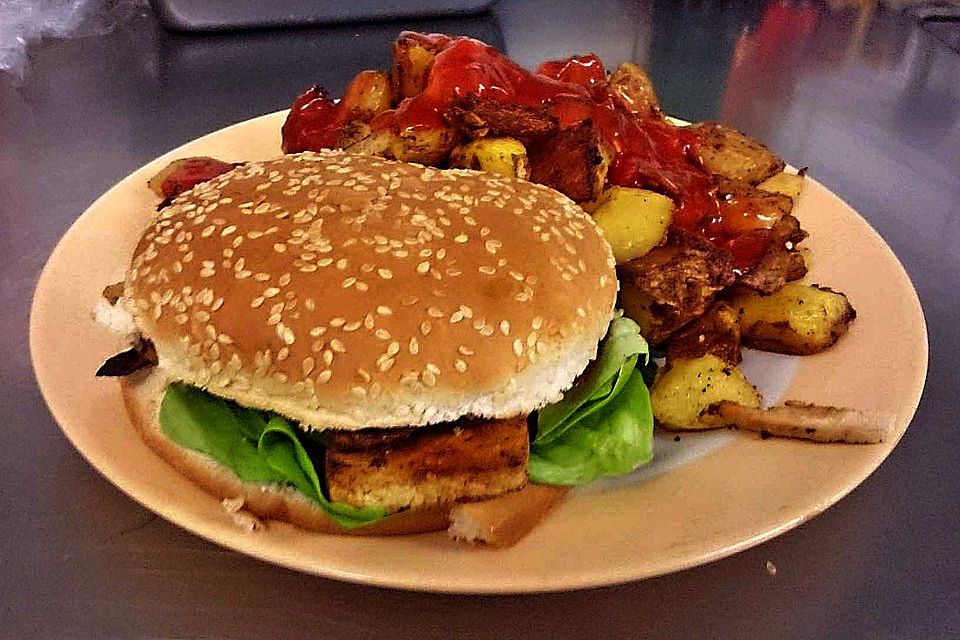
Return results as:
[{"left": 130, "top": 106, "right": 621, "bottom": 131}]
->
[{"left": 160, "top": 384, "right": 387, "bottom": 528}]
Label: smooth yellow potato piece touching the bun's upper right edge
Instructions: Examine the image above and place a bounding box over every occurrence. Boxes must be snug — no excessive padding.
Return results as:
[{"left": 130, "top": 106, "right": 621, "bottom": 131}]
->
[{"left": 591, "top": 187, "right": 674, "bottom": 264}]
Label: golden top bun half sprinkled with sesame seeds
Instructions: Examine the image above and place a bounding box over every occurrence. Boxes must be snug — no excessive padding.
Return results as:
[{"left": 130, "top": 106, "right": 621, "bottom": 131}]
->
[{"left": 126, "top": 151, "right": 617, "bottom": 429}]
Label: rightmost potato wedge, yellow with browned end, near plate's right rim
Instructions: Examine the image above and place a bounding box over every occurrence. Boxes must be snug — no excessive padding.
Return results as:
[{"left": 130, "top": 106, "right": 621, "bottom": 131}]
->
[{"left": 731, "top": 283, "right": 857, "bottom": 355}]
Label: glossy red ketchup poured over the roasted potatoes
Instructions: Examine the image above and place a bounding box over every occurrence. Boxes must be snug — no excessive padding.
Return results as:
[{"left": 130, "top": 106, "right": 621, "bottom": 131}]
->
[{"left": 284, "top": 36, "right": 775, "bottom": 272}]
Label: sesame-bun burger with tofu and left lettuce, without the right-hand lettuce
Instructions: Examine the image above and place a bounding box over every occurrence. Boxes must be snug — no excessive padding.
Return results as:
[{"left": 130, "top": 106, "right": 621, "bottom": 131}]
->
[{"left": 110, "top": 151, "right": 635, "bottom": 534}]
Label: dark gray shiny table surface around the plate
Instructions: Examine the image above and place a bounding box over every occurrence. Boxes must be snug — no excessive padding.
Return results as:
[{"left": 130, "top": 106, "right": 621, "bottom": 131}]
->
[{"left": 0, "top": 0, "right": 960, "bottom": 639}]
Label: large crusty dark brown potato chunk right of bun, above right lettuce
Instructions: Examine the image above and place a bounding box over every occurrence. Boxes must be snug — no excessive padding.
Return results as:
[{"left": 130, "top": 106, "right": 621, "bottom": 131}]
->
[{"left": 617, "top": 233, "right": 734, "bottom": 344}]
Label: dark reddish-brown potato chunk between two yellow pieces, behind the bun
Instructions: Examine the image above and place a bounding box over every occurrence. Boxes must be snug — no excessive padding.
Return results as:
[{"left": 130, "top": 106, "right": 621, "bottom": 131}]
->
[{"left": 528, "top": 122, "right": 610, "bottom": 202}]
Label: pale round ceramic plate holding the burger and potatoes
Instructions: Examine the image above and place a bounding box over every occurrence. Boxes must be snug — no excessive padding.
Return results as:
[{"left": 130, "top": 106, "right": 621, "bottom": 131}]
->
[{"left": 30, "top": 113, "right": 927, "bottom": 593}]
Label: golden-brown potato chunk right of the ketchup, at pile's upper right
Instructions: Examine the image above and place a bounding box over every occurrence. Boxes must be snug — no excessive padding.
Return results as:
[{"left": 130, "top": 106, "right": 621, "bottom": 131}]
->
[{"left": 693, "top": 122, "right": 785, "bottom": 184}]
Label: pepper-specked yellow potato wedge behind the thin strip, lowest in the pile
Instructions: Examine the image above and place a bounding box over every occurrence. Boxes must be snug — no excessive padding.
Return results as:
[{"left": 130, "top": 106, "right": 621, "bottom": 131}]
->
[{"left": 650, "top": 354, "right": 760, "bottom": 430}]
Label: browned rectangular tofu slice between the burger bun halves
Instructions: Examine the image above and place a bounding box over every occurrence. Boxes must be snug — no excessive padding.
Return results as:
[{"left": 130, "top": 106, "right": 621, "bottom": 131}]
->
[{"left": 326, "top": 416, "right": 530, "bottom": 512}]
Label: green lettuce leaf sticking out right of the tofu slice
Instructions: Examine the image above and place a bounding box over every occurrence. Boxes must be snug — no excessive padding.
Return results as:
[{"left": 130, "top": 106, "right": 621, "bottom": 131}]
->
[{"left": 529, "top": 318, "right": 653, "bottom": 485}]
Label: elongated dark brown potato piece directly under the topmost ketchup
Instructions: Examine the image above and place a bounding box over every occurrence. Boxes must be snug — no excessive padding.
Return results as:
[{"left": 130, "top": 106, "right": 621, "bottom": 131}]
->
[{"left": 446, "top": 94, "right": 557, "bottom": 144}]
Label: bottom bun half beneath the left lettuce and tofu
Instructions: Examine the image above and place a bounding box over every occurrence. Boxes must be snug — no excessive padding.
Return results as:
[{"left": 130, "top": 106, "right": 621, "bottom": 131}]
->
[{"left": 120, "top": 367, "right": 453, "bottom": 536}]
